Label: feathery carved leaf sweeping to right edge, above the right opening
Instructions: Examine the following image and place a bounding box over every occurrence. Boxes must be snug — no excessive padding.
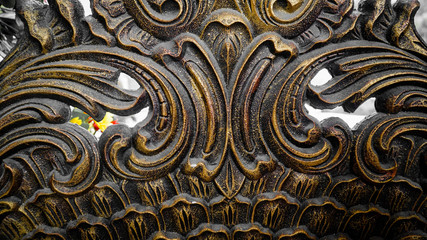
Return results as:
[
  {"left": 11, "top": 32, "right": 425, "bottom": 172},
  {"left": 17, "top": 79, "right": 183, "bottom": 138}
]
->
[{"left": 310, "top": 41, "right": 427, "bottom": 112}]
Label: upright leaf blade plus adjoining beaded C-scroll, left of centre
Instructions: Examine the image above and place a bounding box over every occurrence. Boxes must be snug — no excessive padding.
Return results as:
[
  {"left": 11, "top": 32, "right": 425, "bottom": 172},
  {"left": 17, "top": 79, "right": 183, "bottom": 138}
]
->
[{"left": 100, "top": 35, "right": 227, "bottom": 180}]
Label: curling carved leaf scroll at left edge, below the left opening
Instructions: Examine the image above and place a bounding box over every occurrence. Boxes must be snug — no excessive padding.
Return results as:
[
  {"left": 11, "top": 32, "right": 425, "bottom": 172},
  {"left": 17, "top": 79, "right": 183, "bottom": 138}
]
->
[{"left": 0, "top": 99, "right": 101, "bottom": 195}]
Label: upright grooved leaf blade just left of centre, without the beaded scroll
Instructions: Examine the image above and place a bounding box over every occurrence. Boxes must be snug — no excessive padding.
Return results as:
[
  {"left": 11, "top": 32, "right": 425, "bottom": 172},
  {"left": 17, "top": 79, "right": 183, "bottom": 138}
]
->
[{"left": 153, "top": 34, "right": 228, "bottom": 181}]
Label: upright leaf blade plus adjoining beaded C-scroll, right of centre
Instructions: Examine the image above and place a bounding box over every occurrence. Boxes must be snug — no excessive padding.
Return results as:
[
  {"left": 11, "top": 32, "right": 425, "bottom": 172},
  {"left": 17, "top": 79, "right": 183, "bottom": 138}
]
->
[{"left": 231, "top": 34, "right": 352, "bottom": 178}]
